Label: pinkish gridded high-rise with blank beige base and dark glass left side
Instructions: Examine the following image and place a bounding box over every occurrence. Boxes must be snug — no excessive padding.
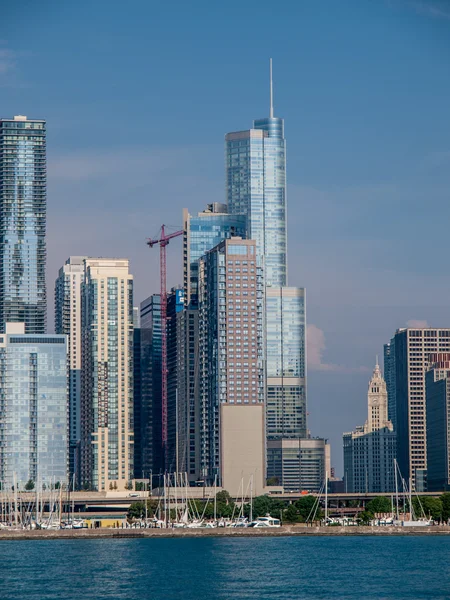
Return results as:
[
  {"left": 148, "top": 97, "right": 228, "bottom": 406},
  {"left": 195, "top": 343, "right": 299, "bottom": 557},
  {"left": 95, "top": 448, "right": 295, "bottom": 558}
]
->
[{"left": 199, "top": 237, "right": 265, "bottom": 493}]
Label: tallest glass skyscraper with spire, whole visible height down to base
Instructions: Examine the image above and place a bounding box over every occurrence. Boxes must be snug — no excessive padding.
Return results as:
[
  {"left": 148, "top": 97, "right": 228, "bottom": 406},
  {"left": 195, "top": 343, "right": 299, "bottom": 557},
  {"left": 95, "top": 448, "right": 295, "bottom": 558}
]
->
[{"left": 225, "top": 62, "right": 307, "bottom": 485}]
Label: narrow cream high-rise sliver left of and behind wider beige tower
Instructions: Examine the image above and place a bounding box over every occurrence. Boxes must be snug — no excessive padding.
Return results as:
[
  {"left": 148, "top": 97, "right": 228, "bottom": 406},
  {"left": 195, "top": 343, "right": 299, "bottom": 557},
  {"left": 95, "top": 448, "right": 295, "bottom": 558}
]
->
[{"left": 55, "top": 256, "right": 86, "bottom": 487}]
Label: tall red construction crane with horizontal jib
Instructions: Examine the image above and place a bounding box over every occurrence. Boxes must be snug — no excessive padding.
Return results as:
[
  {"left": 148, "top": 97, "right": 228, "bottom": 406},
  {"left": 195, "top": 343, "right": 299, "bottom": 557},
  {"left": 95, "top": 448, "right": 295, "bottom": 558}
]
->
[{"left": 147, "top": 225, "right": 184, "bottom": 467}]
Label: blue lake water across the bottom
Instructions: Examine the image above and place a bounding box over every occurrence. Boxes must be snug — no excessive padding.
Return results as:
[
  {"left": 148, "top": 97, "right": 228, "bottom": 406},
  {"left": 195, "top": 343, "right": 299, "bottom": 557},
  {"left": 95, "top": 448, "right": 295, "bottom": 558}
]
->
[{"left": 0, "top": 537, "right": 450, "bottom": 600}]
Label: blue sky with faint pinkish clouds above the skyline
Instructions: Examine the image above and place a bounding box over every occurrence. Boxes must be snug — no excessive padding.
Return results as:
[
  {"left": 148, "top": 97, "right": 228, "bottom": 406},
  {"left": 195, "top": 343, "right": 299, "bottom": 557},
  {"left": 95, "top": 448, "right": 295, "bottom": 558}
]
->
[{"left": 0, "top": 0, "right": 450, "bottom": 474}]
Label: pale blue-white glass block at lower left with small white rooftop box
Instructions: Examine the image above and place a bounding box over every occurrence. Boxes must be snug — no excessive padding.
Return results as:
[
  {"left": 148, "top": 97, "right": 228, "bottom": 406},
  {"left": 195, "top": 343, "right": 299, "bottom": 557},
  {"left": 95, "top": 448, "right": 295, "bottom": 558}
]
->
[{"left": 0, "top": 323, "right": 68, "bottom": 491}]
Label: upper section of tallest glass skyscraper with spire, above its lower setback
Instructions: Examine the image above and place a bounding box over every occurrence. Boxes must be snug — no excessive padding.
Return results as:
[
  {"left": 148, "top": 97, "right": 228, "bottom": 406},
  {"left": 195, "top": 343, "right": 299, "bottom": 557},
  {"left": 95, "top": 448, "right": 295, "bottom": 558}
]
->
[{"left": 225, "top": 62, "right": 287, "bottom": 286}]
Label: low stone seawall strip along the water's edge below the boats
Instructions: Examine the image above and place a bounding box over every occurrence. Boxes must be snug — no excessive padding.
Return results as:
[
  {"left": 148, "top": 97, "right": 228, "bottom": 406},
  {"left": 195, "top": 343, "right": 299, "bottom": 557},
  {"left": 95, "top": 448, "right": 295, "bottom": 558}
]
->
[{"left": 0, "top": 525, "right": 450, "bottom": 541}]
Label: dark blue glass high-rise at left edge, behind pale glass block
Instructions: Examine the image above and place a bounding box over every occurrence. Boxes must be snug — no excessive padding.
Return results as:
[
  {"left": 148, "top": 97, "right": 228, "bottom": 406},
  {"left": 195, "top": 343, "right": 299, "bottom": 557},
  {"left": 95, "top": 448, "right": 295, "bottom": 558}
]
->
[{"left": 0, "top": 115, "right": 47, "bottom": 334}]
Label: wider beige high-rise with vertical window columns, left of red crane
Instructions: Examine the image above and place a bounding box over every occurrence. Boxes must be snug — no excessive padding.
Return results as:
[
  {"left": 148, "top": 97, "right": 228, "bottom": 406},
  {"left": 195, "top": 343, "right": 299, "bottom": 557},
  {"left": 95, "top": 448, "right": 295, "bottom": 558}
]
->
[{"left": 81, "top": 258, "right": 134, "bottom": 491}]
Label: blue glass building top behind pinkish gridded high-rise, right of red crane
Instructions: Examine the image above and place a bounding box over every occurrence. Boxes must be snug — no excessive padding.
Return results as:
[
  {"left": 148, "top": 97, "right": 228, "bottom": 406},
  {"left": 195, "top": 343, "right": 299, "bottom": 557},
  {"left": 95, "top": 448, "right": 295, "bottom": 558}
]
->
[{"left": 183, "top": 202, "right": 247, "bottom": 308}]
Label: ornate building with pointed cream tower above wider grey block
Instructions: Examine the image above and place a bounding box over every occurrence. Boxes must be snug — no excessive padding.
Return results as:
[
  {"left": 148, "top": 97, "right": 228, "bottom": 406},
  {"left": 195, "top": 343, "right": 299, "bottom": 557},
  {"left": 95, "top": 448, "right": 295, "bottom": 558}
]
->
[{"left": 344, "top": 362, "right": 396, "bottom": 493}]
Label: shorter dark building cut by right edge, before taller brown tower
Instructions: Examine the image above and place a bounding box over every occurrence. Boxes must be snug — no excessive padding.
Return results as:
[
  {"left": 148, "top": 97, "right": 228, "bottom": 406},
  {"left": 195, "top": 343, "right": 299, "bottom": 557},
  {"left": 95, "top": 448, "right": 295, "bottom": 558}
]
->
[{"left": 425, "top": 353, "right": 450, "bottom": 492}]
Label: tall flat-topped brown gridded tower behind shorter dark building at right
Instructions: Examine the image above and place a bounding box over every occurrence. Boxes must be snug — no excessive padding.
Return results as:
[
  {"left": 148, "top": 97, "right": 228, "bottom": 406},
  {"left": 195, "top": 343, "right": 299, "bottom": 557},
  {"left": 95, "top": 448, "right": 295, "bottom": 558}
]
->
[{"left": 391, "top": 328, "right": 450, "bottom": 491}]
